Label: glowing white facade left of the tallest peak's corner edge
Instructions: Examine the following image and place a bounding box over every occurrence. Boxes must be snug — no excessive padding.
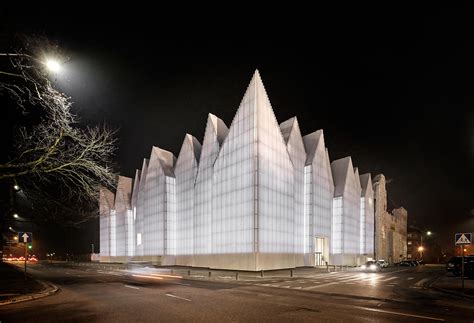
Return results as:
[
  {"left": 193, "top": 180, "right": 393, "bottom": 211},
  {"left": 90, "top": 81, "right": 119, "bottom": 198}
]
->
[{"left": 211, "top": 77, "right": 258, "bottom": 254}]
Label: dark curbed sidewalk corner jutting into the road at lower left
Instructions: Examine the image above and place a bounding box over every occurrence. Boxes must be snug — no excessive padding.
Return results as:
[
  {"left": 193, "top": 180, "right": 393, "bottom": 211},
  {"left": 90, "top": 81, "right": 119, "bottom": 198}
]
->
[{"left": 0, "top": 263, "right": 57, "bottom": 305}]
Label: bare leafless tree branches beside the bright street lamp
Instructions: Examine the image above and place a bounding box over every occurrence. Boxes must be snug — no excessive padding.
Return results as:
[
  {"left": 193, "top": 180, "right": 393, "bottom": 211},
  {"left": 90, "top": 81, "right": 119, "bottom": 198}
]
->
[{"left": 0, "top": 43, "right": 116, "bottom": 222}]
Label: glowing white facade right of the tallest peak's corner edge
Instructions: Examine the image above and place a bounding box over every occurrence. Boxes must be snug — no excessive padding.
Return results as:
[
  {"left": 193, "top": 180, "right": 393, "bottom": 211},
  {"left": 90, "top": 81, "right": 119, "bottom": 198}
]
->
[{"left": 254, "top": 79, "right": 295, "bottom": 253}]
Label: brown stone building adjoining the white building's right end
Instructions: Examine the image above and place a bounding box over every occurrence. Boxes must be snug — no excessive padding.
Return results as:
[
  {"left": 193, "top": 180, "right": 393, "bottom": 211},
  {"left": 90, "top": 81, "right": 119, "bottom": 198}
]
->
[{"left": 373, "top": 174, "right": 408, "bottom": 263}]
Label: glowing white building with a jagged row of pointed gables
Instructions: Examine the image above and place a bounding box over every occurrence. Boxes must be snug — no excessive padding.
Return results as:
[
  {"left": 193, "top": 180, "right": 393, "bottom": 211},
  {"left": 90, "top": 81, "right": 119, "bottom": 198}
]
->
[{"left": 100, "top": 71, "right": 373, "bottom": 271}]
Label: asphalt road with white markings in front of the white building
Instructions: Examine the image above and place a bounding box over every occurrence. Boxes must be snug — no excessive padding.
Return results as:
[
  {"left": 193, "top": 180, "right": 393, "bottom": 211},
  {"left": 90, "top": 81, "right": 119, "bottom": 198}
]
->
[{"left": 0, "top": 264, "right": 474, "bottom": 323}]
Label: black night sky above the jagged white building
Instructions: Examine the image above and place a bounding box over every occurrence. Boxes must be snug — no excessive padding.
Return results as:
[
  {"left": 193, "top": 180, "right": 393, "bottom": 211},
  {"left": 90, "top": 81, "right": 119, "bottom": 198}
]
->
[{"left": 0, "top": 3, "right": 474, "bottom": 254}]
